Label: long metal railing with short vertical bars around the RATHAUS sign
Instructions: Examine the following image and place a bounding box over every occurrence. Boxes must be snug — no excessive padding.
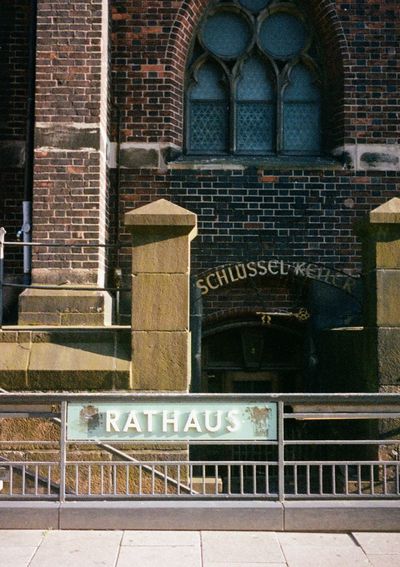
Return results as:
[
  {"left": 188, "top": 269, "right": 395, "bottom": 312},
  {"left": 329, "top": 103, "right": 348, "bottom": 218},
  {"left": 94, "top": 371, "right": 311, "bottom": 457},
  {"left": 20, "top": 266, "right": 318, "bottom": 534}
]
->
[{"left": 0, "top": 393, "right": 400, "bottom": 501}]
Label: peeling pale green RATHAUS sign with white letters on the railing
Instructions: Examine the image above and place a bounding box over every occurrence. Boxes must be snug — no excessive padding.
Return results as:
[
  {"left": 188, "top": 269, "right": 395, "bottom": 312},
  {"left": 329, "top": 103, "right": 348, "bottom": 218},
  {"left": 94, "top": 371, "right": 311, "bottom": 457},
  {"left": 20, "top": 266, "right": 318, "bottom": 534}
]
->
[{"left": 67, "top": 401, "right": 277, "bottom": 442}]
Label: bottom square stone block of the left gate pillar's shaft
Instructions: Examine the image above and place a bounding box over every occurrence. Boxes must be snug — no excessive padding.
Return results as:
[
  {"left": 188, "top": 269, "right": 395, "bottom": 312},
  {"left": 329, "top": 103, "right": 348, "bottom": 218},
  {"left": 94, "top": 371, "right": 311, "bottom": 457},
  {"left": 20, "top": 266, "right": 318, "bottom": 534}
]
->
[{"left": 131, "top": 331, "right": 190, "bottom": 392}]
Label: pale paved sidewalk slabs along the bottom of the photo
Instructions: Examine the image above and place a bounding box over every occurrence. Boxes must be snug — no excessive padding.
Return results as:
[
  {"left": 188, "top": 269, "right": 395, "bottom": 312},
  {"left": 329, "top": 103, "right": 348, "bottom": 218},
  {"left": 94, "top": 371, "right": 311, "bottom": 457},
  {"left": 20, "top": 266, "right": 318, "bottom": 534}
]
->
[{"left": 0, "top": 530, "right": 400, "bottom": 567}]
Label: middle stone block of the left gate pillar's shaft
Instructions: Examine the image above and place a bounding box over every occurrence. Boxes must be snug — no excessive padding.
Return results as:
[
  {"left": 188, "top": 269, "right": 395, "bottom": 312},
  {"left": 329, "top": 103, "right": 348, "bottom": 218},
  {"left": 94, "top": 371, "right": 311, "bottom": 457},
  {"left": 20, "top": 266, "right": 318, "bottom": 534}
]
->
[{"left": 132, "top": 274, "right": 189, "bottom": 331}]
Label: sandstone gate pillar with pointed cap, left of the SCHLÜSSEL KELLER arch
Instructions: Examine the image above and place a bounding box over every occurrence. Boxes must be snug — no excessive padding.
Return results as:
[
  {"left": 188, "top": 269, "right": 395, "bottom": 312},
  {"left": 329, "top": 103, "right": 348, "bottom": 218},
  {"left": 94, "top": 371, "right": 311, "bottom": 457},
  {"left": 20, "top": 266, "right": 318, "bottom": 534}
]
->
[{"left": 125, "top": 199, "right": 197, "bottom": 391}]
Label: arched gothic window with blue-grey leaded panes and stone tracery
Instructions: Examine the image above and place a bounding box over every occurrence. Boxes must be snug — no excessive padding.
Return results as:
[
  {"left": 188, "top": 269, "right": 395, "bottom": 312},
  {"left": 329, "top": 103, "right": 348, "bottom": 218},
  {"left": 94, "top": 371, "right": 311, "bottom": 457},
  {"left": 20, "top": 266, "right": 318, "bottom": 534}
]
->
[{"left": 186, "top": 0, "right": 322, "bottom": 155}]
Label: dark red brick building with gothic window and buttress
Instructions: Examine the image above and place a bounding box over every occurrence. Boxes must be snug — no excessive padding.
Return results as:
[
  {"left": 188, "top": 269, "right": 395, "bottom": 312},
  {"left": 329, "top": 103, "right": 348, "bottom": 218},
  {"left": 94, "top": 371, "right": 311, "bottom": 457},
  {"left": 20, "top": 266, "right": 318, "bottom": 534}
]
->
[{"left": 0, "top": 0, "right": 400, "bottom": 398}]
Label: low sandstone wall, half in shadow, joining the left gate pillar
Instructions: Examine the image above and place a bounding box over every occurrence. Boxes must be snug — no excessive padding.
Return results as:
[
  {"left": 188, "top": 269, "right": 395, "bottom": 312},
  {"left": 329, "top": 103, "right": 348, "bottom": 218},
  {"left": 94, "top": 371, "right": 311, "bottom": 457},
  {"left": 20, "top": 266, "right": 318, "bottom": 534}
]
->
[{"left": 0, "top": 328, "right": 131, "bottom": 391}]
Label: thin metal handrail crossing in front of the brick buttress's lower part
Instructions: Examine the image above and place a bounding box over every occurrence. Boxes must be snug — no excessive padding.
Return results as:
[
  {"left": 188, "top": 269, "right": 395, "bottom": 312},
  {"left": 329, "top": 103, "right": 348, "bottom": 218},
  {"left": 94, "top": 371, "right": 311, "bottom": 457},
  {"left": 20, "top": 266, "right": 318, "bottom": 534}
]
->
[{"left": 0, "top": 227, "right": 131, "bottom": 328}]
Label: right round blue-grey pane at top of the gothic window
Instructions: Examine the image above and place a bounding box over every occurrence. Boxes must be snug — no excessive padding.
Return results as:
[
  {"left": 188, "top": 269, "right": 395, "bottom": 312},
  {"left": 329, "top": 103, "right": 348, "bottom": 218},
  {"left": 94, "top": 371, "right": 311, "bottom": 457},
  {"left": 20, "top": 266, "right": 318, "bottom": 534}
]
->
[{"left": 260, "top": 13, "right": 307, "bottom": 59}]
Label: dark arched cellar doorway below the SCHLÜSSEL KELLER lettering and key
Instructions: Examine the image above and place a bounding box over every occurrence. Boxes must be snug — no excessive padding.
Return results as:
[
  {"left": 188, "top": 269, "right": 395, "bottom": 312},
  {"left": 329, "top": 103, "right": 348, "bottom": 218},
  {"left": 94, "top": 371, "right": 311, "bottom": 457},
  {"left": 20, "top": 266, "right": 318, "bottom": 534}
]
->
[{"left": 202, "top": 317, "right": 307, "bottom": 394}]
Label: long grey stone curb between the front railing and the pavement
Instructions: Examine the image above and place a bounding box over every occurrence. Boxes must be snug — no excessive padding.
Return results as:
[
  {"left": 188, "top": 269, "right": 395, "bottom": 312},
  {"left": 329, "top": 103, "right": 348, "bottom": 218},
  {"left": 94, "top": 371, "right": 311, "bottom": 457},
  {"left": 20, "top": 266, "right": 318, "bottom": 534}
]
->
[{"left": 0, "top": 500, "right": 400, "bottom": 532}]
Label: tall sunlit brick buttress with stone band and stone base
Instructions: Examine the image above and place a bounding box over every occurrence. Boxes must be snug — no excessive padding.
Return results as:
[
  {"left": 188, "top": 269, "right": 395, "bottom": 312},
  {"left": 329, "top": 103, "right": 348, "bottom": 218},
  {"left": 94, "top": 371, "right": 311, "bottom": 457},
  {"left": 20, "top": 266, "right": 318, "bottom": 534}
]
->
[{"left": 19, "top": 0, "right": 111, "bottom": 326}]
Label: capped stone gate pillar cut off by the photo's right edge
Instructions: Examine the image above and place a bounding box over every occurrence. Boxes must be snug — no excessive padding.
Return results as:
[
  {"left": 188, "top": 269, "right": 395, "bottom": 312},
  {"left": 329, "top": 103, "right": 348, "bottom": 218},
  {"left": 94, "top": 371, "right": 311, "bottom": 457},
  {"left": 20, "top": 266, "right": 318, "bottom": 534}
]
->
[{"left": 362, "top": 198, "right": 400, "bottom": 392}]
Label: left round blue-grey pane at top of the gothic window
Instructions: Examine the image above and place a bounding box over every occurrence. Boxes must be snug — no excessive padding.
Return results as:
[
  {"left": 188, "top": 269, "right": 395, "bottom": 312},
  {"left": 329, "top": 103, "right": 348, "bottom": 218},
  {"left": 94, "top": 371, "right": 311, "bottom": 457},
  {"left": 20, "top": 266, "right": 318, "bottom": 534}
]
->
[{"left": 202, "top": 11, "right": 251, "bottom": 59}]
